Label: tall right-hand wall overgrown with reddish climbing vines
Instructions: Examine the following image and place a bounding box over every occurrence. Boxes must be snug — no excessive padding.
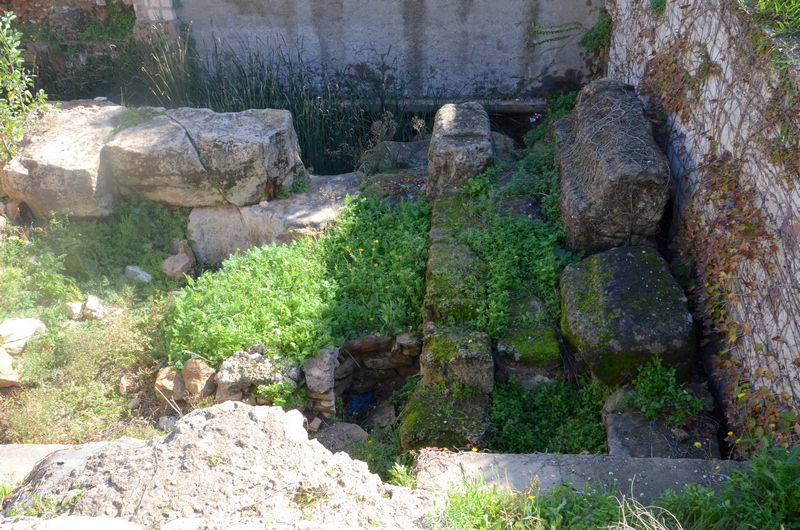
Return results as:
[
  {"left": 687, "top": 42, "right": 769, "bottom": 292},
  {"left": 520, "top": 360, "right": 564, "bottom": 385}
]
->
[{"left": 608, "top": 0, "right": 800, "bottom": 437}]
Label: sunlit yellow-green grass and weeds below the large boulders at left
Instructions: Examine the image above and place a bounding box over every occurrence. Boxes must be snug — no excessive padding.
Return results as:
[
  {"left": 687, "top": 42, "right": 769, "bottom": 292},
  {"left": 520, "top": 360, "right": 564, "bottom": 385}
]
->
[{"left": 0, "top": 198, "right": 188, "bottom": 443}]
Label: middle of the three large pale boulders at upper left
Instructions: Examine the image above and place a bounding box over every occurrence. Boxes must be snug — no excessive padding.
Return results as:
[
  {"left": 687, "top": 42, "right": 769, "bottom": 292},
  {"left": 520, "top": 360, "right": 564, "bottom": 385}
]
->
[{"left": 103, "top": 116, "right": 225, "bottom": 208}]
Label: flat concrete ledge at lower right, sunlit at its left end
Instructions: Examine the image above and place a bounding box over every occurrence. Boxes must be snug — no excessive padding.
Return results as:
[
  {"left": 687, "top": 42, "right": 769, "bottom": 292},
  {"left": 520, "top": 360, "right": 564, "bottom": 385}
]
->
[{"left": 414, "top": 451, "right": 746, "bottom": 504}]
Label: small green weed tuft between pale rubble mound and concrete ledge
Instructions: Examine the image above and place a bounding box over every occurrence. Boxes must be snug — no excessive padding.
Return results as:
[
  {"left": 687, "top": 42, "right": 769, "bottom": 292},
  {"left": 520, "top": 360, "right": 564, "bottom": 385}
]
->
[{"left": 348, "top": 427, "right": 417, "bottom": 488}]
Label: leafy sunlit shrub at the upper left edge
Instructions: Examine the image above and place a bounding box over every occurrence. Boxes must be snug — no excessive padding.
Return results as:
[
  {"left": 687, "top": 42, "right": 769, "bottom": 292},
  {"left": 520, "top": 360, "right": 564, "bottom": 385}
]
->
[{"left": 0, "top": 11, "right": 47, "bottom": 166}]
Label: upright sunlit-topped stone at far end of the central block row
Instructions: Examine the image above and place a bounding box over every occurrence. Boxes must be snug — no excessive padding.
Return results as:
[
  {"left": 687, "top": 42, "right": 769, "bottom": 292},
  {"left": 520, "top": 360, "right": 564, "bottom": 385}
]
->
[{"left": 425, "top": 102, "right": 494, "bottom": 201}]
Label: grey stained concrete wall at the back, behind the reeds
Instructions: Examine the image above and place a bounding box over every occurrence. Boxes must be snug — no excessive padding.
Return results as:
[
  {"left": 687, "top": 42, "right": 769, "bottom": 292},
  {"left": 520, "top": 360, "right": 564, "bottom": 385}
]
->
[{"left": 135, "top": 0, "right": 604, "bottom": 97}]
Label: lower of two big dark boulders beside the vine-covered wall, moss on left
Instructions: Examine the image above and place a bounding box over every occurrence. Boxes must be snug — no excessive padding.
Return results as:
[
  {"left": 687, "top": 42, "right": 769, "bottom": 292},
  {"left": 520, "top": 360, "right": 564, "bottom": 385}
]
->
[{"left": 561, "top": 247, "right": 696, "bottom": 385}]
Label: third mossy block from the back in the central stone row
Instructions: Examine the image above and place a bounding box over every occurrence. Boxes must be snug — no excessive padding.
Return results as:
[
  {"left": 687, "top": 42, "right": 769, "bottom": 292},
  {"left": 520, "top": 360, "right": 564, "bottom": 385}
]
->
[{"left": 422, "top": 243, "right": 487, "bottom": 327}]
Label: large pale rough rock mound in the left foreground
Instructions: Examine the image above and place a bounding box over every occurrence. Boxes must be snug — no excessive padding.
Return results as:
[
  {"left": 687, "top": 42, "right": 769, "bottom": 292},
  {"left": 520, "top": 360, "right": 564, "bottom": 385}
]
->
[{"left": 4, "top": 402, "right": 444, "bottom": 530}]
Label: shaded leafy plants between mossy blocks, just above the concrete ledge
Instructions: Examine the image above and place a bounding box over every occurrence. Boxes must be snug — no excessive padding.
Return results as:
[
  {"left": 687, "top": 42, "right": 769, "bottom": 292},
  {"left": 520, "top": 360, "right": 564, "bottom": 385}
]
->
[{"left": 489, "top": 378, "right": 612, "bottom": 453}]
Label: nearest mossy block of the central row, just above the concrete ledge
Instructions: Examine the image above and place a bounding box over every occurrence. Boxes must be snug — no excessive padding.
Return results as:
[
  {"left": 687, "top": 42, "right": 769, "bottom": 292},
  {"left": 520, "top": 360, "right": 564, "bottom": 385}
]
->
[{"left": 399, "top": 384, "right": 489, "bottom": 451}]
